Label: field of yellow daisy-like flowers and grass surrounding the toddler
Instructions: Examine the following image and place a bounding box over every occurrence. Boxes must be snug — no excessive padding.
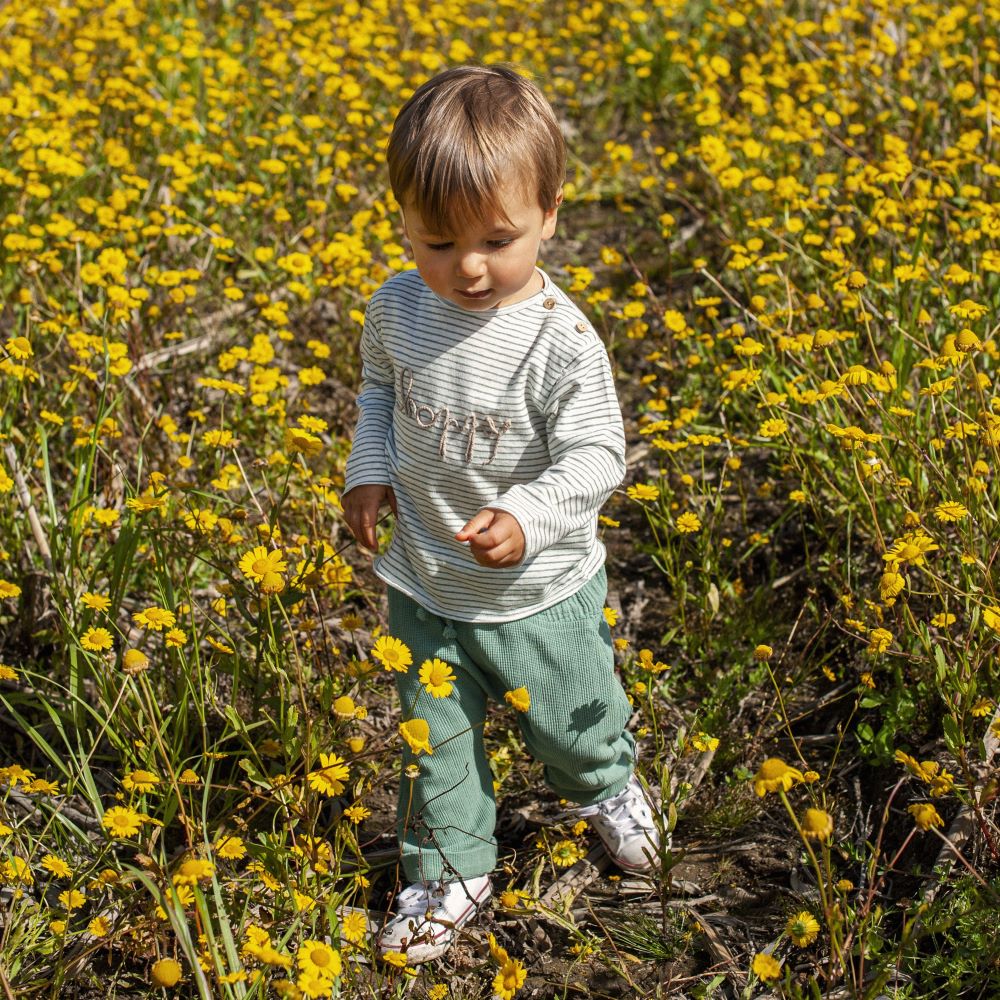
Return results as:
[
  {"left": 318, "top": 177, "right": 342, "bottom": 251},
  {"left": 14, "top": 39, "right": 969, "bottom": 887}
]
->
[{"left": 0, "top": 0, "right": 1000, "bottom": 1000}]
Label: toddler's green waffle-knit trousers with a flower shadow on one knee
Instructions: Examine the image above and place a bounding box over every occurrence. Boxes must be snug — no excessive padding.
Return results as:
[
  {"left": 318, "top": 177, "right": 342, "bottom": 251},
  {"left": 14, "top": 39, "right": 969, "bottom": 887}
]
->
[{"left": 389, "top": 569, "right": 635, "bottom": 882}]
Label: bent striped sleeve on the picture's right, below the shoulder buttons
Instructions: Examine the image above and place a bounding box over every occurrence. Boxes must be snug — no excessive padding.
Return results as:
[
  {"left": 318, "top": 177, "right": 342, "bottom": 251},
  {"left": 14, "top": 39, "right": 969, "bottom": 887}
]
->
[{"left": 487, "top": 343, "right": 625, "bottom": 559}]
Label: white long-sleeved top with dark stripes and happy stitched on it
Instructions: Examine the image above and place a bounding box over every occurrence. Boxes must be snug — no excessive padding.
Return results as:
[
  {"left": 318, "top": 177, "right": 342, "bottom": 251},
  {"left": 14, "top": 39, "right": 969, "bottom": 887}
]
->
[{"left": 345, "top": 271, "right": 625, "bottom": 622}]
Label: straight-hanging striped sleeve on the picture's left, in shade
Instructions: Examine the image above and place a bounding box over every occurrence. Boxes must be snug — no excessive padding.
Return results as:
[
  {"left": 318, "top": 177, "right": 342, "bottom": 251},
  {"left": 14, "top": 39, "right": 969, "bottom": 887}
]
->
[{"left": 344, "top": 299, "right": 396, "bottom": 493}]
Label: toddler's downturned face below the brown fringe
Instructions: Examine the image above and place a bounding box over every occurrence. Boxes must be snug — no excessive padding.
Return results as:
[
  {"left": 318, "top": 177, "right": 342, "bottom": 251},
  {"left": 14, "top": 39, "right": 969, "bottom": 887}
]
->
[{"left": 403, "top": 187, "right": 558, "bottom": 312}]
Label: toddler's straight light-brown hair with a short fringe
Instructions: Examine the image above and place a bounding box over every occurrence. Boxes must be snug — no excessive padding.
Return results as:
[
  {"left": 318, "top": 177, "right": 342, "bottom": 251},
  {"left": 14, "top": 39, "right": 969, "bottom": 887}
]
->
[{"left": 386, "top": 66, "right": 566, "bottom": 234}]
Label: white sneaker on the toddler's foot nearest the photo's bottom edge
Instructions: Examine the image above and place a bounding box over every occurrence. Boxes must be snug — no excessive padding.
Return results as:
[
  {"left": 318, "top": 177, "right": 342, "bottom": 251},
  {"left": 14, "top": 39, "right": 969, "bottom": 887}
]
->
[{"left": 379, "top": 875, "right": 493, "bottom": 965}]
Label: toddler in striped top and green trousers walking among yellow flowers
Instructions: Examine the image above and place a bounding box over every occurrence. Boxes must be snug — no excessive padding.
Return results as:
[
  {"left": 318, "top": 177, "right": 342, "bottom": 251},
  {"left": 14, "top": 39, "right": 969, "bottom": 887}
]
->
[{"left": 343, "top": 60, "right": 658, "bottom": 963}]
